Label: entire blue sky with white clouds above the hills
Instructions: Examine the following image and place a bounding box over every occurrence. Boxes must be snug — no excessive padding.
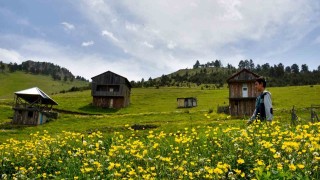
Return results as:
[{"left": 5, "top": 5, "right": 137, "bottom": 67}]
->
[{"left": 0, "top": 0, "right": 320, "bottom": 81}]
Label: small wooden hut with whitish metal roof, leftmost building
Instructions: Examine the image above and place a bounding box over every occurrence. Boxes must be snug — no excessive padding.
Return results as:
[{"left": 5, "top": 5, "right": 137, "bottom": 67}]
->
[{"left": 12, "top": 87, "right": 58, "bottom": 125}]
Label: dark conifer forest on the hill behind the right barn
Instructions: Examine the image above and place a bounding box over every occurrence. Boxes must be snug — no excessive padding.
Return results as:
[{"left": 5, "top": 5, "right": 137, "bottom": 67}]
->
[{"left": 131, "top": 59, "right": 320, "bottom": 88}]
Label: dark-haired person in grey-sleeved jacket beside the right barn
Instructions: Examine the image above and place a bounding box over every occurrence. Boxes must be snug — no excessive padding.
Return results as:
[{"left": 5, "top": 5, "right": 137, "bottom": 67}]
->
[{"left": 247, "top": 77, "right": 273, "bottom": 124}]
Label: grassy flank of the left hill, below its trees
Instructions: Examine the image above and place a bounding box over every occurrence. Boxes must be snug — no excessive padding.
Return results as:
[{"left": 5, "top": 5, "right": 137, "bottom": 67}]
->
[{"left": 0, "top": 71, "right": 88, "bottom": 99}]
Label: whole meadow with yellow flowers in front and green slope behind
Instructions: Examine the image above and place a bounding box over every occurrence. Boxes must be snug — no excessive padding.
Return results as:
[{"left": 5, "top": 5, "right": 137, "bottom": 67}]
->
[{"left": 0, "top": 85, "right": 320, "bottom": 179}]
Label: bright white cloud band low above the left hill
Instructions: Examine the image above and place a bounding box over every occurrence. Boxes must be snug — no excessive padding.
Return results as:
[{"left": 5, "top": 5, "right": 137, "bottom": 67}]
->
[{"left": 0, "top": 35, "right": 150, "bottom": 81}]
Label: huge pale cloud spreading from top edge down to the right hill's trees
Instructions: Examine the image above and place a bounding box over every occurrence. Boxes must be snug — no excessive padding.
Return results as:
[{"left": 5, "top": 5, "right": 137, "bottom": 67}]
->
[{"left": 68, "top": 0, "right": 319, "bottom": 74}]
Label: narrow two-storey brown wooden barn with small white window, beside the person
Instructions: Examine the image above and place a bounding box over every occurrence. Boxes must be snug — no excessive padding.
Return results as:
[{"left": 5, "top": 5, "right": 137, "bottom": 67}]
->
[{"left": 227, "top": 69, "right": 260, "bottom": 117}]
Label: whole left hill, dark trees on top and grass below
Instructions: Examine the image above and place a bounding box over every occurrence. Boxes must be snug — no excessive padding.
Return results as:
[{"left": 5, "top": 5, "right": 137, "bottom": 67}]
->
[{"left": 0, "top": 61, "right": 90, "bottom": 99}]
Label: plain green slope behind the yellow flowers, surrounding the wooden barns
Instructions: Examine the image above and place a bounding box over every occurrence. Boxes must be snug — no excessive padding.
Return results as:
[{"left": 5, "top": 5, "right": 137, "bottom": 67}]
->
[{"left": 0, "top": 86, "right": 320, "bottom": 142}]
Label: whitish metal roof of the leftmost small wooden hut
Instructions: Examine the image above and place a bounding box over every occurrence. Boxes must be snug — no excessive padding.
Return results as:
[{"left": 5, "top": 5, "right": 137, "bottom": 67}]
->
[{"left": 14, "top": 87, "right": 58, "bottom": 105}]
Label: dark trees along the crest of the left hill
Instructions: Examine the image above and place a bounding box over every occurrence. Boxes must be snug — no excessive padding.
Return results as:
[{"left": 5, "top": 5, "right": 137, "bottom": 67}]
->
[{"left": 0, "top": 60, "right": 88, "bottom": 81}]
